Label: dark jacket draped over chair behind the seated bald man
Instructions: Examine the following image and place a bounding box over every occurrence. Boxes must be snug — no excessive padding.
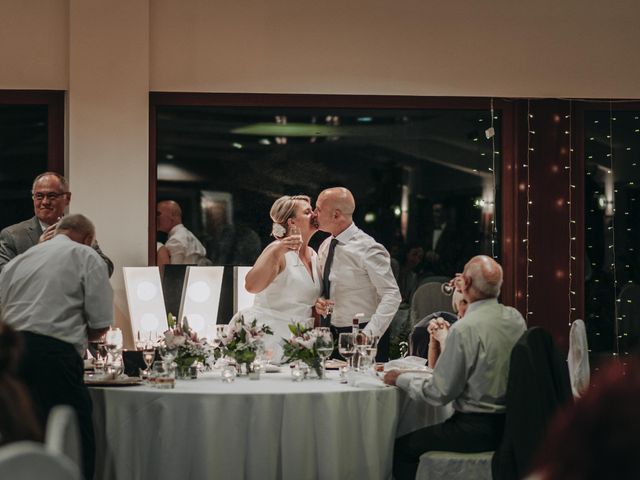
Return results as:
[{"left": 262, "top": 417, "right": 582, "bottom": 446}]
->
[{"left": 492, "top": 327, "right": 573, "bottom": 480}]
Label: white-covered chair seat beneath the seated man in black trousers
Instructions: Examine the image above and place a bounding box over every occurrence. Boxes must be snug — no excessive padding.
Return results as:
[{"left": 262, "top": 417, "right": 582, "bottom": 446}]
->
[{"left": 416, "top": 452, "right": 493, "bottom": 480}]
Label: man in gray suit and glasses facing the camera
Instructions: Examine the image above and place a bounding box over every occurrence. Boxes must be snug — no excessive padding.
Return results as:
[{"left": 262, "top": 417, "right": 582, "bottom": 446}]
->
[{"left": 0, "top": 172, "right": 113, "bottom": 276}]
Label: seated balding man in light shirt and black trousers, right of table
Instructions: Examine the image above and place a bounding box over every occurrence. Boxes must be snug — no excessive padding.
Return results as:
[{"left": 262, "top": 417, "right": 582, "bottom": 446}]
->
[{"left": 384, "top": 255, "right": 526, "bottom": 480}]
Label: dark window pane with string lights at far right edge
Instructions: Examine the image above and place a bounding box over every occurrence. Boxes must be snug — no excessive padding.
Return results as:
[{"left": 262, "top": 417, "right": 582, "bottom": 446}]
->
[{"left": 584, "top": 111, "right": 640, "bottom": 354}]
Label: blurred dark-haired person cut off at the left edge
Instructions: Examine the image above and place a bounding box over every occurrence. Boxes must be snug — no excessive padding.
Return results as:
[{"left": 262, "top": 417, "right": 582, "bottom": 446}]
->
[{"left": 0, "top": 321, "right": 42, "bottom": 446}]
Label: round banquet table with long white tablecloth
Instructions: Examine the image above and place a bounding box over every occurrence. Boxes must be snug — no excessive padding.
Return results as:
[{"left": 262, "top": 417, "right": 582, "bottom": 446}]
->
[{"left": 89, "top": 367, "right": 452, "bottom": 480}]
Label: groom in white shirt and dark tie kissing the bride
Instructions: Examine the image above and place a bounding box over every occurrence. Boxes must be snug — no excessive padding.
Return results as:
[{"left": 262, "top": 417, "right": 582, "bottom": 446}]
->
[{"left": 315, "top": 187, "right": 402, "bottom": 361}]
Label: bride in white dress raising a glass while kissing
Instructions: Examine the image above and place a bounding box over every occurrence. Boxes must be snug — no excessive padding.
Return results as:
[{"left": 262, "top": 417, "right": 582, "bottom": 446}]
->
[{"left": 241, "top": 195, "right": 322, "bottom": 363}]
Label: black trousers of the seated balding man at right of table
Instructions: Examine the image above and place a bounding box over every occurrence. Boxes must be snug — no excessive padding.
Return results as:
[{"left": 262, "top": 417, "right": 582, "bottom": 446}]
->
[{"left": 393, "top": 412, "right": 504, "bottom": 480}]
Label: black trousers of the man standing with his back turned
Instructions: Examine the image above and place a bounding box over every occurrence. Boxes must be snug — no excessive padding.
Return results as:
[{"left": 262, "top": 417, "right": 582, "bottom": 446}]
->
[{"left": 18, "top": 332, "right": 95, "bottom": 480}]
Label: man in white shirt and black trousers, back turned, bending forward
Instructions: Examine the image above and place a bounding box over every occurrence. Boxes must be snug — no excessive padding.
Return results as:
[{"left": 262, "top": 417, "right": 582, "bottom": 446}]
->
[{"left": 0, "top": 214, "right": 113, "bottom": 478}]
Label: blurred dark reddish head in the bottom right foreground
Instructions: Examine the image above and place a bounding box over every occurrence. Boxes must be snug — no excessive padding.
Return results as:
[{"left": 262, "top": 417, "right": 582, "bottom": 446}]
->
[{"left": 528, "top": 358, "right": 640, "bottom": 480}]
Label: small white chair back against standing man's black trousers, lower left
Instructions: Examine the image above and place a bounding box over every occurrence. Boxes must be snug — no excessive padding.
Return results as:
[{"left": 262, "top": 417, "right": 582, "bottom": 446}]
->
[{"left": 44, "top": 405, "right": 82, "bottom": 468}]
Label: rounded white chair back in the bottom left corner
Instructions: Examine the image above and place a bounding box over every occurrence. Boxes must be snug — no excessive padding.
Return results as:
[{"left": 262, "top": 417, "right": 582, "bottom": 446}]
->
[{"left": 0, "top": 442, "right": 82, "bottom": 480}]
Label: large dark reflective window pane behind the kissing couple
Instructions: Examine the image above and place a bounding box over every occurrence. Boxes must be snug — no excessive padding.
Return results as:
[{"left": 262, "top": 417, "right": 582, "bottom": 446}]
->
[{"left": 157, "top": 106, "right": 501, "bottom": 286}]
